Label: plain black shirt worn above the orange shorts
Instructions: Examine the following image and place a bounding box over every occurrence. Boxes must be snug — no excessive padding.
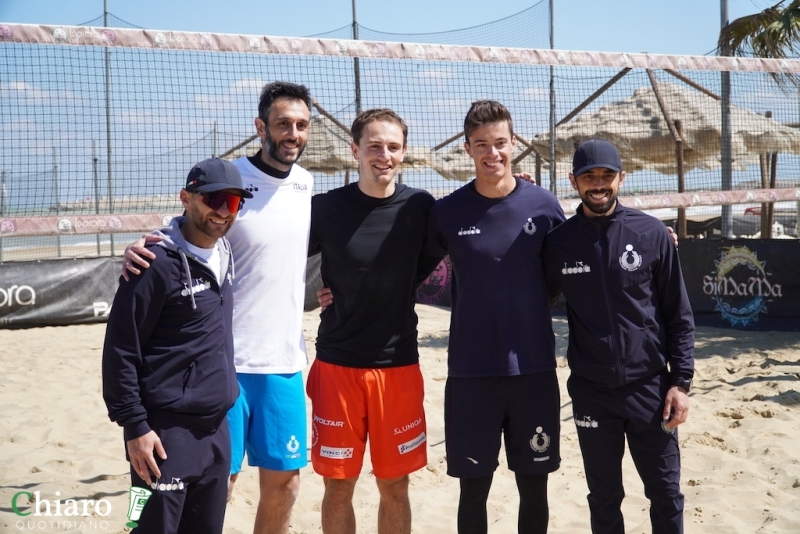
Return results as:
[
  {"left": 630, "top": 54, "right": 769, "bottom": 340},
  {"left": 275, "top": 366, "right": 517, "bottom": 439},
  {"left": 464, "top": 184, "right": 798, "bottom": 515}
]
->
[{"left": 309, "top": 183, "right": 441, "bottom": 368}]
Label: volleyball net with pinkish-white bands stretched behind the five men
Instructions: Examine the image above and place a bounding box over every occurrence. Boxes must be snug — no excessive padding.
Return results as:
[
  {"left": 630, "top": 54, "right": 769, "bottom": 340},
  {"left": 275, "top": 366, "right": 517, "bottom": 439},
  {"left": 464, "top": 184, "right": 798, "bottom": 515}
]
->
[{"left": 0, "top": 23, "right": 800, "bottom": 261}]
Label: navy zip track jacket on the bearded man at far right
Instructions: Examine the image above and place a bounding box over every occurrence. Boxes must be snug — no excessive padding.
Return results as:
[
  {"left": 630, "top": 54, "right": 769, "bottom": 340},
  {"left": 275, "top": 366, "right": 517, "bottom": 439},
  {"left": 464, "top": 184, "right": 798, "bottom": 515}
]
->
[{"left": 545, "top": 202, "right": 694, "bottom": 387}]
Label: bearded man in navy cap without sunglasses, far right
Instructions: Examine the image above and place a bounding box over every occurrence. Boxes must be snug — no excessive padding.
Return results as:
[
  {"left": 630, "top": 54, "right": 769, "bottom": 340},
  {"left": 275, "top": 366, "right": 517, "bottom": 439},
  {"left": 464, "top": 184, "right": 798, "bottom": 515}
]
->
[{"left": 544, "top": 139, "right": 694, "bottom": 534}]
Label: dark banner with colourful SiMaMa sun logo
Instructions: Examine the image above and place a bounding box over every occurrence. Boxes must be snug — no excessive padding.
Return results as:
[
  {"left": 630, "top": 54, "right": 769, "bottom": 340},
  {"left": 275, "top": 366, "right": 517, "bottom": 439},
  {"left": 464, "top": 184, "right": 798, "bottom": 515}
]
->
[{"left": 678, "top": 239, "right": 800, "bottom": 331}]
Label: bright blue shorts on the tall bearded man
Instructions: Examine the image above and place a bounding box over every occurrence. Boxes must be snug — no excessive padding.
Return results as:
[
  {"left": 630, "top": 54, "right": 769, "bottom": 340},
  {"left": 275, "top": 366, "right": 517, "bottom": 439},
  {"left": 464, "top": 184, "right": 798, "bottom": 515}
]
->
[{"left": 228, "top": 372, "right": 308, "bottom": 474}]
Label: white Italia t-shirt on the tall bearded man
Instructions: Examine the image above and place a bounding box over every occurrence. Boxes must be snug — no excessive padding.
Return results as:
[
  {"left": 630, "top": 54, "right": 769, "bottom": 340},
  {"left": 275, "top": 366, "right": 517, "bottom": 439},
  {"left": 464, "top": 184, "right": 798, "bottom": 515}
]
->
[{"left": 226, "top": 158, "right": 314, "bottom": 374}]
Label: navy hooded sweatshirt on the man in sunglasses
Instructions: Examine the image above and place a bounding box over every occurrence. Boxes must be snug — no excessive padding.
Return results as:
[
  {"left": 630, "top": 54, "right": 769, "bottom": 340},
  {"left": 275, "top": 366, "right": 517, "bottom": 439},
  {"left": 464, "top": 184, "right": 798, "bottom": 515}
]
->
[{"left": 103, "top": 217, "right": 239, "bottom": 441}]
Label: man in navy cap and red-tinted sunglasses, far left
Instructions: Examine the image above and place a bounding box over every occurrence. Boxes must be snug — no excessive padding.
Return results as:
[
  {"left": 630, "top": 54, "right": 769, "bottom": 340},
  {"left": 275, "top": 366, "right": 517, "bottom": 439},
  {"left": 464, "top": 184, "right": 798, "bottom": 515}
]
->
[{"left": 103, "top": 159, "right": 252, "bottom": 534}]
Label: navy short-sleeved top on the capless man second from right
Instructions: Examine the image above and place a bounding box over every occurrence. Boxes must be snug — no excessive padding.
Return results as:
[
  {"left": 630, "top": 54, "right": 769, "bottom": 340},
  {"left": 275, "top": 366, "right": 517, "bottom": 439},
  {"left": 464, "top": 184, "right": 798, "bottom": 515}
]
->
[{"left": 426, "top": 180, "right": 564, "bottom": 377}]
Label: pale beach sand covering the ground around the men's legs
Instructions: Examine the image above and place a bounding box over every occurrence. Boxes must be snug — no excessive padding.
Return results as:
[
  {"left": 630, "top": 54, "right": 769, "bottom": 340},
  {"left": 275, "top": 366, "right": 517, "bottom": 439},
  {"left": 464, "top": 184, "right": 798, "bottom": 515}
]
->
[{"left": 0, "top": 306, "right": 800, "bottom": 534}]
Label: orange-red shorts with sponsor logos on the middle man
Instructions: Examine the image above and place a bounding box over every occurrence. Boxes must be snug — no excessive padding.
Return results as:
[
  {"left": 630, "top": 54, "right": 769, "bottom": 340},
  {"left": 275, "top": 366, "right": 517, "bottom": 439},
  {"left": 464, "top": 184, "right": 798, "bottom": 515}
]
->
[{"left": 306, "top": 360, "right": 428, "bottom": 479}]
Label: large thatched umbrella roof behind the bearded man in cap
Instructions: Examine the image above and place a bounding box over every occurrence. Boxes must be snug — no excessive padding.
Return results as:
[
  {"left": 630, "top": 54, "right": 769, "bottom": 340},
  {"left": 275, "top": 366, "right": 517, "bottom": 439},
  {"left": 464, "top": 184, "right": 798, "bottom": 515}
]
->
[{"left": 533, "top": 82, "right": 800, "bottom": 174}]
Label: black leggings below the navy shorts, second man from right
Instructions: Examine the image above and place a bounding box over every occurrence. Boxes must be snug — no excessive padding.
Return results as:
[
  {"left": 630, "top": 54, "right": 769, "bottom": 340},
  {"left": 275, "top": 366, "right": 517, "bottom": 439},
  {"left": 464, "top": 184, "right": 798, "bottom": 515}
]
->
[{"left": 458, "top": 473, "right": 550, "bottom": 534}]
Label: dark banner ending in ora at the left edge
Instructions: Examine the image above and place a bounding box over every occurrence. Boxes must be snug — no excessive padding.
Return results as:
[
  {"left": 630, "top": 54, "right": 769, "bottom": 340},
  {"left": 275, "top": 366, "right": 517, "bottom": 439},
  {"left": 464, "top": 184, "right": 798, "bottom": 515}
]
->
[{"left": 0, "top": 258, "right": 122, "bottom": 328}]
